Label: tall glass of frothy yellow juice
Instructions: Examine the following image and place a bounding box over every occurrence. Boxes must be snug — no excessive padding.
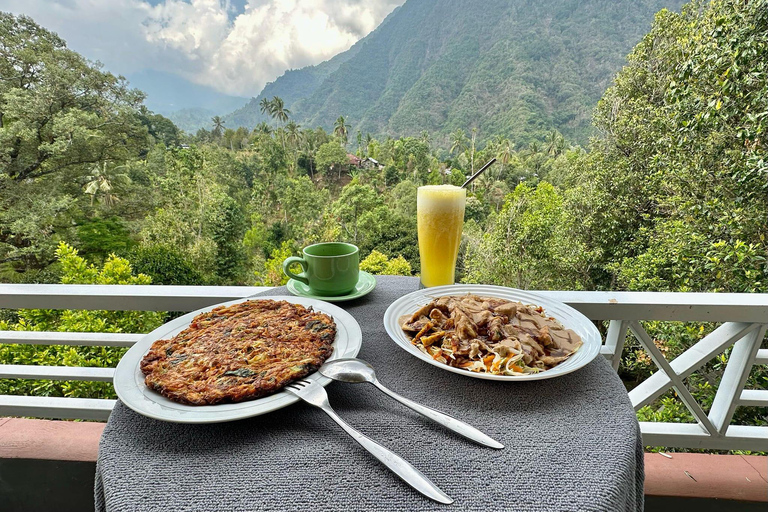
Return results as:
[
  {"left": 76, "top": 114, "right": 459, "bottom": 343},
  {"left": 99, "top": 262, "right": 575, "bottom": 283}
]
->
[{"left": 416, "top": 185, "right": 467, "bottom": 288}]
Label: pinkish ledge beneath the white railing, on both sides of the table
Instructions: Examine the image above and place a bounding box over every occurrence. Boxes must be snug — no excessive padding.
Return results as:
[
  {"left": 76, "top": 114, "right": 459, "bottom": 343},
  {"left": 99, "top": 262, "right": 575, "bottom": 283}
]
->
[{"left": 0, "top": 418, "right": 768, "bottom": 510}]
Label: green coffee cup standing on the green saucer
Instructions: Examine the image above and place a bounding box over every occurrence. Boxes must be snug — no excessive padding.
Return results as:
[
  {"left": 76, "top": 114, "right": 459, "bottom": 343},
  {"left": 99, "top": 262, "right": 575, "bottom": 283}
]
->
[{"left": 283, "top": 242, "right": 360, "bottom": 296}]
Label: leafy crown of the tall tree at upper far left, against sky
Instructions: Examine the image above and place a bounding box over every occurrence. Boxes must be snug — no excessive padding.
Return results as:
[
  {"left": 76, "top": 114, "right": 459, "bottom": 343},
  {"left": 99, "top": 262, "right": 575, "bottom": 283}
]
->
[{"left": 0, "top": 13, "right": 147, "bottom": 182}]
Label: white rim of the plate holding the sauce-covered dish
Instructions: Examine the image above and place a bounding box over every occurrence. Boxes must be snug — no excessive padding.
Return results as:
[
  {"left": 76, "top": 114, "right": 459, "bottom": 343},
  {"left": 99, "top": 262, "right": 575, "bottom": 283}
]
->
[{"left": 383, "top": 284, "right": 603, "bottom": 382}]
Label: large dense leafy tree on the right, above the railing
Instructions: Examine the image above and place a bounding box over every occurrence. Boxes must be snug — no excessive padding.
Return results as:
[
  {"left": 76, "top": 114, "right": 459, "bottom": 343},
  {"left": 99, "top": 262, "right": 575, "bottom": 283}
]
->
[{"left": 566, "top": 0, "right": 768, "bottom": 291}]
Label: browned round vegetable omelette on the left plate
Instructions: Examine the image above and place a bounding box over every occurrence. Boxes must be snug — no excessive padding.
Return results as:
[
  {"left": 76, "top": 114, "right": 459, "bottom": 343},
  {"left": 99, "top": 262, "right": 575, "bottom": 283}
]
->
[{"left": 141, "top": 300, "right": 336, "bottom": 405}]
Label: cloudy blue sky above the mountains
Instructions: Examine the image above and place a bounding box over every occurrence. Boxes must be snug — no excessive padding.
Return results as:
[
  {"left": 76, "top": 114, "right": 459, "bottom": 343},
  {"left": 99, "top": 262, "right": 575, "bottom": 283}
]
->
[{"left": 0, "top": 0, "right": 405, "bottom": 96}]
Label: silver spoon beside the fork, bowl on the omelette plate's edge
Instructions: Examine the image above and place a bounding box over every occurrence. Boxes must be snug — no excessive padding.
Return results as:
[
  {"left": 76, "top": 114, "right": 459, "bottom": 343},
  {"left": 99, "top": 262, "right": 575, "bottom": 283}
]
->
[{"left": 318, "top": 358, "right": 504, "bottom": 449}]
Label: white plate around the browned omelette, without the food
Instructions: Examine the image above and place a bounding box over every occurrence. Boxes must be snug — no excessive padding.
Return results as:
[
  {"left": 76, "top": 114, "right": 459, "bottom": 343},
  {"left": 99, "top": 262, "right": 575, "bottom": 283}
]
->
[{"left": 114, "top": 296, "right": 363, "bottom": 423}]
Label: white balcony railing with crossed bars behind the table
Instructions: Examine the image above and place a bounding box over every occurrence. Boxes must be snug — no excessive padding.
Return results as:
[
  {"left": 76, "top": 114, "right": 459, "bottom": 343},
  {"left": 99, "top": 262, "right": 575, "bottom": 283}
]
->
[{"left": 0, "top": 285, "right": 768, "bottom": 451}]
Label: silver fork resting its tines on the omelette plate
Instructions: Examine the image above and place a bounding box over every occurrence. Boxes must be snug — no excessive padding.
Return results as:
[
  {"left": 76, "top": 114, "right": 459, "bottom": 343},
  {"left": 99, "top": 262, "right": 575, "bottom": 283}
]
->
[{"left": 285, "top": 379, "right": 453, "bottom": 504}]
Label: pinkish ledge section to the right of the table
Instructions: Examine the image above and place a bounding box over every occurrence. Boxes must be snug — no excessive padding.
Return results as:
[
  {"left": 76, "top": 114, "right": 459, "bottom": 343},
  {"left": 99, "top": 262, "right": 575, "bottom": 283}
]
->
[{"left": 645, "top": 453, "right": 768, "bottom": 501}]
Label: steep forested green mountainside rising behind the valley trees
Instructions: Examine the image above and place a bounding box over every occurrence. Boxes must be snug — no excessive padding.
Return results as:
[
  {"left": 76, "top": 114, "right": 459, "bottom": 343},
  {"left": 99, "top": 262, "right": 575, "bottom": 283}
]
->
[{"left": 225, "top": 0, "right": 683, "bottom": 147}]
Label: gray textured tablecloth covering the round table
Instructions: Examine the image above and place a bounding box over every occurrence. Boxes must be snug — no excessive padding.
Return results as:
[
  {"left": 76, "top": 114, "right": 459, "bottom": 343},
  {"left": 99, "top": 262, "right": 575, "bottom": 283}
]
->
[{"left": 95, "top": 277, "right": 643, "bottom": 512}]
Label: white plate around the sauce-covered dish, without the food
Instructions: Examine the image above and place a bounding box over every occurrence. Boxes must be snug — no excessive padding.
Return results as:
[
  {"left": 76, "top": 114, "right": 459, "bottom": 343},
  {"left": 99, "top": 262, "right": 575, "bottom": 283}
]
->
[{"left": 384, "top": 284, "right": 602, "bottom": 381}]
